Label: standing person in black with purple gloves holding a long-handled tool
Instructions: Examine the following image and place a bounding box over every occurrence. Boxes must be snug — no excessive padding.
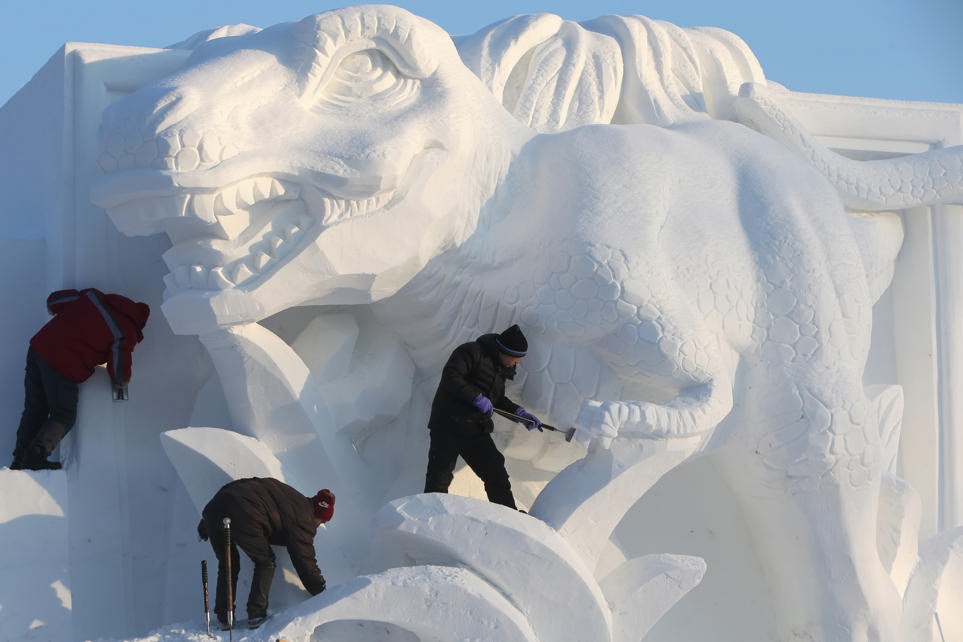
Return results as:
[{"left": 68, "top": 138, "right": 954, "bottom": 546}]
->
[{"left": 425, "top": 325, "right": 541, "bottom": 508}]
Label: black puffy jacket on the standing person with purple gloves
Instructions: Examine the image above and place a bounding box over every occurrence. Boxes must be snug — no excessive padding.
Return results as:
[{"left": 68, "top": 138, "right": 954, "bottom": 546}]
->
[{"left": 428, "top": 334, "right": 519, "bottom": 437}]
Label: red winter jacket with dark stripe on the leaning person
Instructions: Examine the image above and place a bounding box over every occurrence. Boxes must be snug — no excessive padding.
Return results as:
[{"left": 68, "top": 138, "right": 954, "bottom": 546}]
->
[{"left": 30, "top": 288, "right": 150, "bottom": 383}]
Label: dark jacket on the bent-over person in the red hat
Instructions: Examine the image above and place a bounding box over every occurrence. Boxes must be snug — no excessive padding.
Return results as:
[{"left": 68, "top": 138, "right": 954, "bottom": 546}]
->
[{"left": 198, "top": 477, "right": 325, "bottom": 595}]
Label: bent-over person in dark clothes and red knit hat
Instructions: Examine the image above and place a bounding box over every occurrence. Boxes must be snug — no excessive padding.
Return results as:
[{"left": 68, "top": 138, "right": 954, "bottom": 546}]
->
[{"left": 197, "top": 477, "right": 334, "bottom": 630}]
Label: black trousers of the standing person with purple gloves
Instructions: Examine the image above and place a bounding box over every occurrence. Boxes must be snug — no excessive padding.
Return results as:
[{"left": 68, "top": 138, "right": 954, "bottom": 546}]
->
[{"left": 425, "top": 430, "right": 516, "bottom": 508}]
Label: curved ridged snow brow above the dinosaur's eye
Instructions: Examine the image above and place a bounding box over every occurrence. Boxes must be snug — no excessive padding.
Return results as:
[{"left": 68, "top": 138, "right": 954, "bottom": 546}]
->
[{"left": 295, "top": 5, "right": 444, "bottom": 102}]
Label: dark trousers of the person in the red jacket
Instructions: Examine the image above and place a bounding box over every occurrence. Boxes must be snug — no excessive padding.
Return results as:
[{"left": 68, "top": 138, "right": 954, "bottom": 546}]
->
[{"left": 13, "top": 348, "right": 80, "bottom": 460}]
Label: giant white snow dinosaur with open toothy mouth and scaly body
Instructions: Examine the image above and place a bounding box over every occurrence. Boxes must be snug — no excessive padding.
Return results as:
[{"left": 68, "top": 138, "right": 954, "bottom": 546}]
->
[{"left": 94, "top": 7, "right": 963, "bottom": 640}]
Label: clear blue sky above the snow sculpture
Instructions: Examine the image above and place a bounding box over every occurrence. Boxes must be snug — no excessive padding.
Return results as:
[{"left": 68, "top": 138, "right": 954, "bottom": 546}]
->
[{"left": 0, "top": 0, "right": 963, "bottom": 104}]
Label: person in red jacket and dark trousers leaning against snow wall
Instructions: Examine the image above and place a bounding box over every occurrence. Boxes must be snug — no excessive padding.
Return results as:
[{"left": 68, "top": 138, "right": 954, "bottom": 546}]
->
[{"left": 10, "top": 288, "right": 150, "bottom": 470}]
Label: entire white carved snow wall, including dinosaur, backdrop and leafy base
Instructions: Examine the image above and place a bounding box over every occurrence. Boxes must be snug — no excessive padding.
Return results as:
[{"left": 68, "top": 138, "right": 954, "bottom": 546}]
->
[{"left": 0, "top": 6, "right": 963, "bottom": 642}]
